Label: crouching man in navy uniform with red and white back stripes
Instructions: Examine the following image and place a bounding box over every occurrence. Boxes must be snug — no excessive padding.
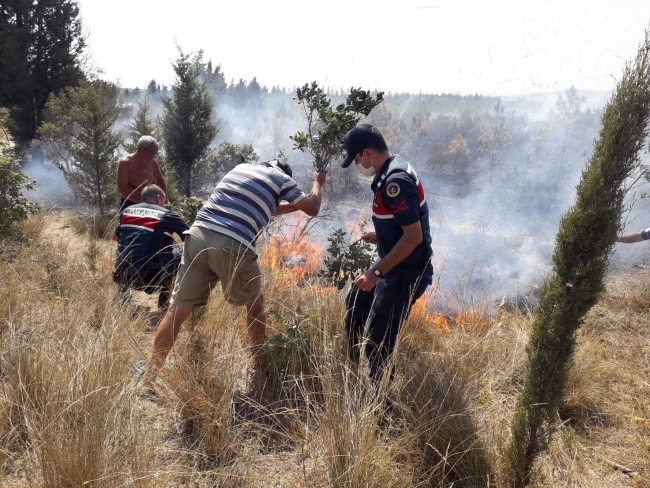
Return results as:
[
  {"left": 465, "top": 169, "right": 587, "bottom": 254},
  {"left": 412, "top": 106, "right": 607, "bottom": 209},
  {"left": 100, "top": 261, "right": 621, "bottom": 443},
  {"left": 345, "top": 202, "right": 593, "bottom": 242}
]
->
[{"left": 113, "top": 185, "right": 188, "bottom": 310}]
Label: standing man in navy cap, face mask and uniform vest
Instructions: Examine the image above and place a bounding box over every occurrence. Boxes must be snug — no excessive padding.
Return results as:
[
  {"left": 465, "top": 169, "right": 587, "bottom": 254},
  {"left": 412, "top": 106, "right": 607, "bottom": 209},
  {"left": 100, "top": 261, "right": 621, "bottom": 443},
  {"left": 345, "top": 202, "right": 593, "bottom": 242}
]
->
[{"left": 341, "top": 124, "right": 433, "bottom": 382}]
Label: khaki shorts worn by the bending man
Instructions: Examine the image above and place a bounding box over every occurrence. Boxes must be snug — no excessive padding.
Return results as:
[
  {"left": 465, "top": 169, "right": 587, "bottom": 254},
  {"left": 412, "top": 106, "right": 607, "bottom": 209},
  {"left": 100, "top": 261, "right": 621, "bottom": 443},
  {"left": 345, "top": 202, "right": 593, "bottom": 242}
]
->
[{"left": 171, "top": 227, "right": 262, "bottom": 306}]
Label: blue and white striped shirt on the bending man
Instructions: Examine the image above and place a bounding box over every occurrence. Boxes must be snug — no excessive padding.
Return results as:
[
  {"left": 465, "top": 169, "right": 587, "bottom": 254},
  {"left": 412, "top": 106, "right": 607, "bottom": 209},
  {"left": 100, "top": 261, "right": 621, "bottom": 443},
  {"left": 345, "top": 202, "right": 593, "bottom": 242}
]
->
[{"left": 194, "top": 163, "right": 305, "bottom": 248}]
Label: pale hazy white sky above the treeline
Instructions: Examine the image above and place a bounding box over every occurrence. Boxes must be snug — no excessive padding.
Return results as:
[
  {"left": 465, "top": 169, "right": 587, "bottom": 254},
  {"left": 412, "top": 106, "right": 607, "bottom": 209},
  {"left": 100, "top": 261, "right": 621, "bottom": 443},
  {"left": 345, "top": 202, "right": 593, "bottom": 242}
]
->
[{"left": 79, "top": 0, "right": 650, "bottom": 95}]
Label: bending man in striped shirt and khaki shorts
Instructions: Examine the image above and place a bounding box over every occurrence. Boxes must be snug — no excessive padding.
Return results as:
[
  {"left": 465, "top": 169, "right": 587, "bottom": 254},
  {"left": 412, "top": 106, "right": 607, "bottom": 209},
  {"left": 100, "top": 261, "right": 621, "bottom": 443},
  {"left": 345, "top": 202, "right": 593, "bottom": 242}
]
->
[{"left": 139, "top": 160, "right": 325, "bottom": 389}]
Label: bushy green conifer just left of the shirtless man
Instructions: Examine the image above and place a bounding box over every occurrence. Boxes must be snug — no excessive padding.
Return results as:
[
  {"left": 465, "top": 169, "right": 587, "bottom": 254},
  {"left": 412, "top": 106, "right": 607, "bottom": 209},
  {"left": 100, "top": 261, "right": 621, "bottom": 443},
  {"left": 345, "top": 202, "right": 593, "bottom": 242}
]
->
[{"left": 39, "top": 80, "right": 122, "bottom": 213}]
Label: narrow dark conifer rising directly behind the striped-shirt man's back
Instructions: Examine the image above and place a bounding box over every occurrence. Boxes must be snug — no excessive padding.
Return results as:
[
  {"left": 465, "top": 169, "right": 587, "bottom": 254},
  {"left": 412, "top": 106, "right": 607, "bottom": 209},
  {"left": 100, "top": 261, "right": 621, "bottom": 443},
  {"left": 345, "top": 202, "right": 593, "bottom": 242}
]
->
[{"left": 163, "top": 48, "right": 218, "bottom": 197}]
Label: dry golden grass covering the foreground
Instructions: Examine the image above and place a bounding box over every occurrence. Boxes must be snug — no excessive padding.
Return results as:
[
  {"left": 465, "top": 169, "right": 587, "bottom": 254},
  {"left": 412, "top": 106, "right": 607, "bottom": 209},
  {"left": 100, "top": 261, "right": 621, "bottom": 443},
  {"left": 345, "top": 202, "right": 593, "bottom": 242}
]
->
[{"left": 0, "top": 214, "right": 650, "bottom": 488}]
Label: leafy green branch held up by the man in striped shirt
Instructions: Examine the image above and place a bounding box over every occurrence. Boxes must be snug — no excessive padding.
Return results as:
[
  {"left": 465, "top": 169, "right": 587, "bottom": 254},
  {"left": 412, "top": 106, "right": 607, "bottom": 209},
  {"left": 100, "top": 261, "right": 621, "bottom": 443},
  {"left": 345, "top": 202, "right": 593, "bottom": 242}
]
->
[{"left": 291, "top": 81, "right": 384, "bottom": 171}]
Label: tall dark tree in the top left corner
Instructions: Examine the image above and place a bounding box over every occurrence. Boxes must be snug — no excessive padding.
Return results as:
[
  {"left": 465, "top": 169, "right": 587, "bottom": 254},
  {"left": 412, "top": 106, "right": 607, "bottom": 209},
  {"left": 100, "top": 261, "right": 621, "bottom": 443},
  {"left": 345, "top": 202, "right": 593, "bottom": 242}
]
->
[{"left": 0, "top": 0, "right": 86, "bottom": 147}]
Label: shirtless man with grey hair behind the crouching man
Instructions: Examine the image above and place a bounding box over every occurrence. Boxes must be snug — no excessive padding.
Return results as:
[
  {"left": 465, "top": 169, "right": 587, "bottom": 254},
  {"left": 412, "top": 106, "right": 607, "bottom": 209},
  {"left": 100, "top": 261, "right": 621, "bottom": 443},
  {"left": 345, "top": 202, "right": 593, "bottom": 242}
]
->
[{"left": 117, "top": 136, "right": 167, "bottom": 211}]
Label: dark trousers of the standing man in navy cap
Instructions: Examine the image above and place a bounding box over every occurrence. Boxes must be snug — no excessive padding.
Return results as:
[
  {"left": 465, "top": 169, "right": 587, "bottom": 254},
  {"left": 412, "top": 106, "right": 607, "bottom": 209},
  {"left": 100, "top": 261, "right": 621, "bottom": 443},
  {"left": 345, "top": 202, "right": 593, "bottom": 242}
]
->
[{"left": 345, "top": 263, "right": 433, "bottom": 382}]
